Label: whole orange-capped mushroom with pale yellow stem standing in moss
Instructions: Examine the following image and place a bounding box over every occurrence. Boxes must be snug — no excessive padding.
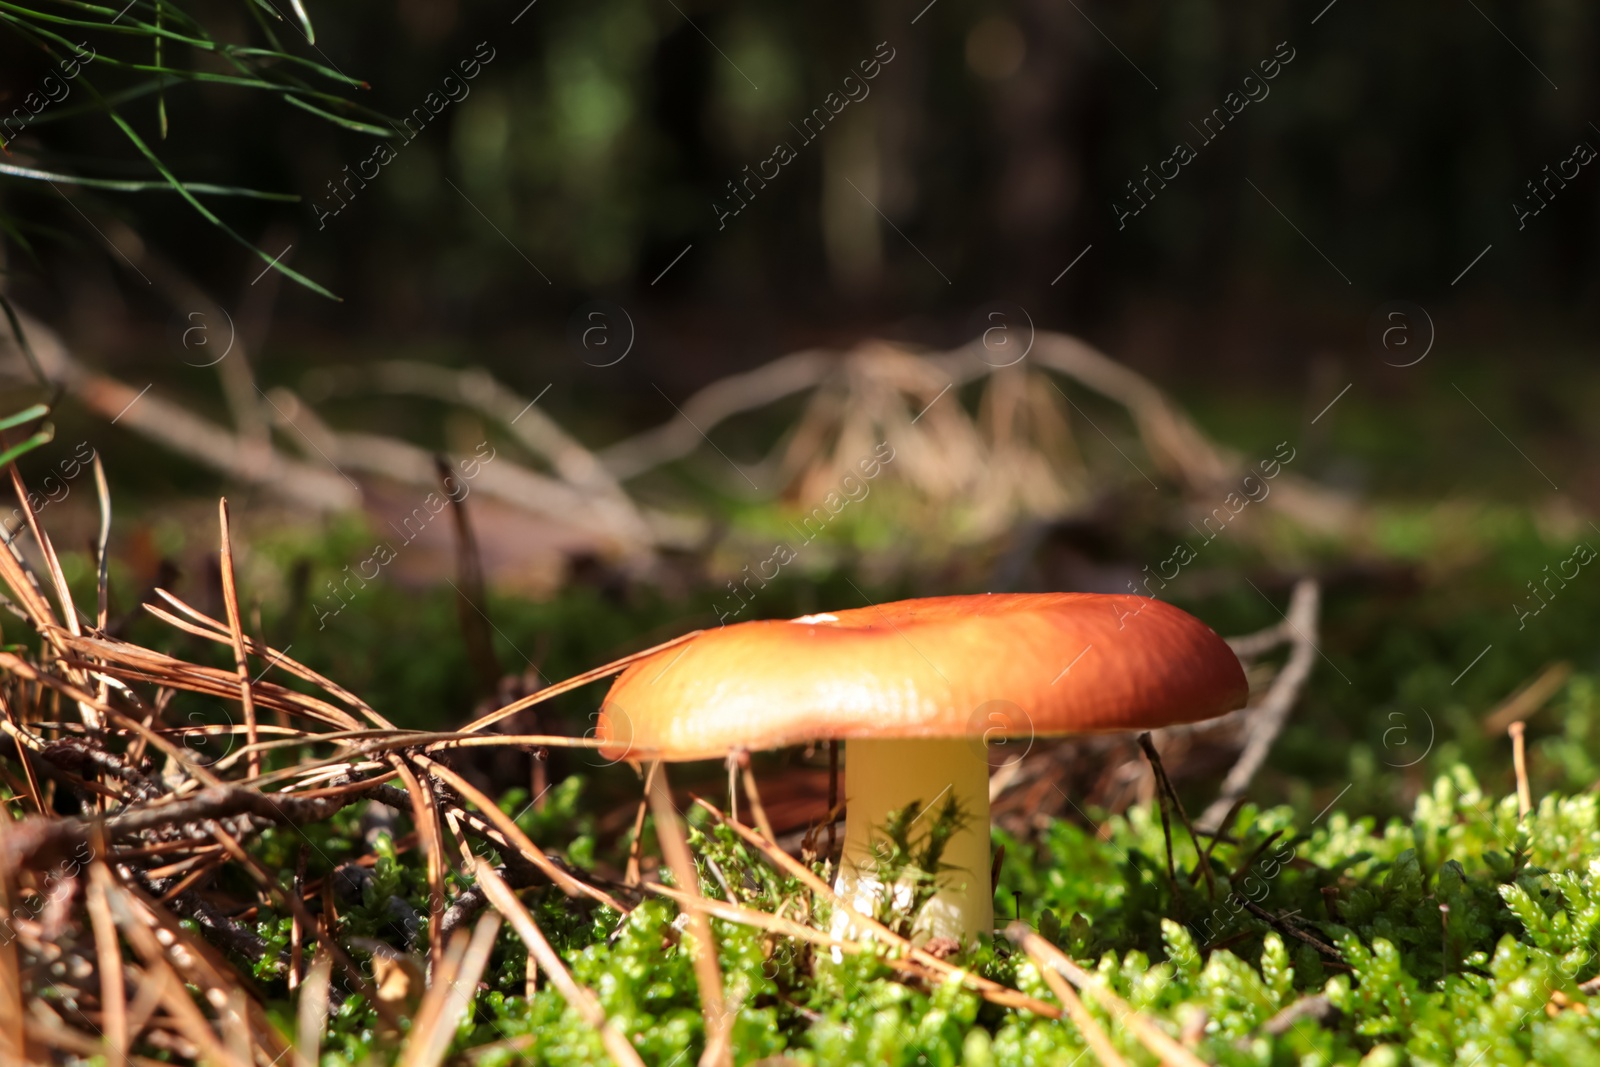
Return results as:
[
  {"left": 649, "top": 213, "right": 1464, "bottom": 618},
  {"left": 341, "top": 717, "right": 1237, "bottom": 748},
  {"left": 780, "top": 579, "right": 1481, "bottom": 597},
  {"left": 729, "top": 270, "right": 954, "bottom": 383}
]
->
[{"left": 595, "top": 593, "right": 1246, "bottom": 945}]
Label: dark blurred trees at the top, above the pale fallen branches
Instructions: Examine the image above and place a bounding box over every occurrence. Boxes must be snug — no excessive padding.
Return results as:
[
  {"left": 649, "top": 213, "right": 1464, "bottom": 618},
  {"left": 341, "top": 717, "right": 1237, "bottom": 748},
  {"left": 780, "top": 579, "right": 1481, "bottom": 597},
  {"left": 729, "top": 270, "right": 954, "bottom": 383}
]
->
[{"left": 0, "top": 0, "right": 1600, "bottom": 379}]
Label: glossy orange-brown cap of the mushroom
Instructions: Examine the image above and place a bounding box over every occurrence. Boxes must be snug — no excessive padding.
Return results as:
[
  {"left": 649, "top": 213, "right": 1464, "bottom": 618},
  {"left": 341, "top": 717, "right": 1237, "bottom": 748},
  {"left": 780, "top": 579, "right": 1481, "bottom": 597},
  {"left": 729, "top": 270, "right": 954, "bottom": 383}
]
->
[{"left": 595, "top": 593, "right": 1248, "bottom": 760}]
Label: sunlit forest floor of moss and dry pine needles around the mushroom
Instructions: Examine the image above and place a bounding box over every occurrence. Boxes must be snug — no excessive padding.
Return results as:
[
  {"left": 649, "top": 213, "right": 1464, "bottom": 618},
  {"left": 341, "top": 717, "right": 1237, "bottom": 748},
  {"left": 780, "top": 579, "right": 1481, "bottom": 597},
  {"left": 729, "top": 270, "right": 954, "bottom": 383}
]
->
[{"left": 12, "top": 358, "right": 1600, "bottom": 1065}]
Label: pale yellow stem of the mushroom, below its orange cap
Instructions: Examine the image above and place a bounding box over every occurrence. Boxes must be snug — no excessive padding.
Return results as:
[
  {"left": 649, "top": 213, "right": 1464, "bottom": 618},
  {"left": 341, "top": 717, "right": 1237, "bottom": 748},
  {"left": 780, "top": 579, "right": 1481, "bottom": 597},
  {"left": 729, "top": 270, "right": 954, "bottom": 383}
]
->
[{"left": 834, "top": 737, "right": 994, "bottom": 947}]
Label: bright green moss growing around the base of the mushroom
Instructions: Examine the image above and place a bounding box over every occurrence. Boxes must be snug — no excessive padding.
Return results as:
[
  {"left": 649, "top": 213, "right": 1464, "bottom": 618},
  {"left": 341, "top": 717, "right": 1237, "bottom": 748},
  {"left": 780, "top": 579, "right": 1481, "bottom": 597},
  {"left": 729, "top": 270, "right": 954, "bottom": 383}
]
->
[{"left": 258, "top": 768, "right": 1600, "bottom": 1067}]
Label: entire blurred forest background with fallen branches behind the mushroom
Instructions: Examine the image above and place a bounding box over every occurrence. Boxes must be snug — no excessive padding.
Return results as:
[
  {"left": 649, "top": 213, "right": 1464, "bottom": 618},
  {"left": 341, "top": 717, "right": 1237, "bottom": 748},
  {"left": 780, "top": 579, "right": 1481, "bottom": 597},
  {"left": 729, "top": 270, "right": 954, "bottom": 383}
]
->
[{"left": 0, "top": 0, "right": 1600, "bottom": 811}]
